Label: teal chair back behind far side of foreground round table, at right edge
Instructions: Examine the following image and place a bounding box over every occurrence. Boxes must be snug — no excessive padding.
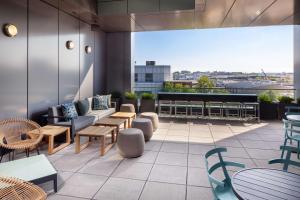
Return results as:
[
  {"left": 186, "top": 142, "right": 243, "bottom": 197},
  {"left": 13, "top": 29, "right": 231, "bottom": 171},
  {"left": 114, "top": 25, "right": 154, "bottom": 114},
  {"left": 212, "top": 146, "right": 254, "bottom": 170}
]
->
[{"left": 269, "top": 146, "right": 300, "bottom": 171}]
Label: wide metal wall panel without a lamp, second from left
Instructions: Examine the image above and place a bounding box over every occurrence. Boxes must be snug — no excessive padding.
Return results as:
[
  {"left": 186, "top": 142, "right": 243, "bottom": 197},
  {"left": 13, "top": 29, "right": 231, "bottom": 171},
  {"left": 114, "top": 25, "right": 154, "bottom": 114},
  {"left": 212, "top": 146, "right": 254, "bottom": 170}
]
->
[{"left": 28, "top": 0, "right": 58, "bottom": 118}]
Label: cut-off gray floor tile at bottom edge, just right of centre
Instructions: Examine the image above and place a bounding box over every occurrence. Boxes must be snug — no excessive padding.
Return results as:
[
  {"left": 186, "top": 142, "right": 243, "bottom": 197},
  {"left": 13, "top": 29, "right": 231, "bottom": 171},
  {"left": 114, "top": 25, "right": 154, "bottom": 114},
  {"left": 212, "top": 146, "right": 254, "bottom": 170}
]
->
[{"left": 140, "top": 182, "right": 186, "bottom": 200}]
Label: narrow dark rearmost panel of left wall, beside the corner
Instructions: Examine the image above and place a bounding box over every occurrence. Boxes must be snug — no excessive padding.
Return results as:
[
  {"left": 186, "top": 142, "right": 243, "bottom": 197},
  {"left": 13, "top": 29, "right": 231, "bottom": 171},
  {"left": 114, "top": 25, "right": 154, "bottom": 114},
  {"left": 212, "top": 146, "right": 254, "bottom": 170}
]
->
[{"left": 94, "top": 31, "right": 106, "bottom": 94}]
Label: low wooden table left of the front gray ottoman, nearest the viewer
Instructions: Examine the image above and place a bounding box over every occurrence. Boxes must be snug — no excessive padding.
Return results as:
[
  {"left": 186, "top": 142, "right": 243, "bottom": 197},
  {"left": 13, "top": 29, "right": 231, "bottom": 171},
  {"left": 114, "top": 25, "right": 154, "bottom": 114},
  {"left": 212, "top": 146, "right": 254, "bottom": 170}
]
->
[{"left": 75, "top": 126, "right": 116, "bottom": 156}]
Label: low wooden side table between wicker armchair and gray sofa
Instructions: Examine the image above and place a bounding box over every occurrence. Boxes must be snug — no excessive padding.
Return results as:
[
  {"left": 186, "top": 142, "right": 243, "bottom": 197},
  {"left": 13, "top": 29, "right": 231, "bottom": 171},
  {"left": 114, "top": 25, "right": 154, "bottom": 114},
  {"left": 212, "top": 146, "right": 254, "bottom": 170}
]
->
[{"left": 30, "top": 125, "right": 71, "bottom": 155}]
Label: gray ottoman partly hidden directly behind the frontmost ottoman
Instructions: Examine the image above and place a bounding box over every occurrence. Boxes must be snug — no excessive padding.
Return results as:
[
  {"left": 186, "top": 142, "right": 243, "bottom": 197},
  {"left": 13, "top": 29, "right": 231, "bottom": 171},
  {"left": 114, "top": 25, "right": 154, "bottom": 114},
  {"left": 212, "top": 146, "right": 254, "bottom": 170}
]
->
[{"left": 131, "top": 118, "right": 153, "bottom": 142}]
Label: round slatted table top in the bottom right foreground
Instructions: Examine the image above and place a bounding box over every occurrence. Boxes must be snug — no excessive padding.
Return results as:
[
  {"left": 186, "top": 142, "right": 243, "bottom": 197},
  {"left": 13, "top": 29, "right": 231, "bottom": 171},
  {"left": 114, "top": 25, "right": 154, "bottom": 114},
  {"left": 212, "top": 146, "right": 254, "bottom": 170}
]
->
[{"left": 232, "top": 168, "right": 300, "bottom": 200}]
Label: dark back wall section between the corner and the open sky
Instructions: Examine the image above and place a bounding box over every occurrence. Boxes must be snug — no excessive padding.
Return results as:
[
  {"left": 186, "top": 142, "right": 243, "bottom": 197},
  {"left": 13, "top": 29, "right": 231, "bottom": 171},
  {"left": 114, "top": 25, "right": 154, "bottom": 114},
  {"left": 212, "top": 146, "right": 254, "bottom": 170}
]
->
[{"left": 106, "top": 32, "right": 133, "bottom": 93}]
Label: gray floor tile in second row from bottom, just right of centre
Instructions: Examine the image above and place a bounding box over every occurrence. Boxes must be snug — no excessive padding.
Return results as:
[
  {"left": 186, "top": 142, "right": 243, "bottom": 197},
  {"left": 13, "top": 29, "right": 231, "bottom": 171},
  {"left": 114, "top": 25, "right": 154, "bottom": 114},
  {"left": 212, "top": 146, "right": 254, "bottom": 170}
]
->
[{"left": 149, "top": 165, "right": 187, "bottom": 184}]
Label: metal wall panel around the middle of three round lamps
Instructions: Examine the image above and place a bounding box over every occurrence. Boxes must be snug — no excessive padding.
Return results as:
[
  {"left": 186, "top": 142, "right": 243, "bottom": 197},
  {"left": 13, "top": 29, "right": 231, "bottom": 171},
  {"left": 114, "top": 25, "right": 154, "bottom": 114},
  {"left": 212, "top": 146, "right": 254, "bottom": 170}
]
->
[{"left": 59, "top": 12, "right": 80, "bottom": 103}]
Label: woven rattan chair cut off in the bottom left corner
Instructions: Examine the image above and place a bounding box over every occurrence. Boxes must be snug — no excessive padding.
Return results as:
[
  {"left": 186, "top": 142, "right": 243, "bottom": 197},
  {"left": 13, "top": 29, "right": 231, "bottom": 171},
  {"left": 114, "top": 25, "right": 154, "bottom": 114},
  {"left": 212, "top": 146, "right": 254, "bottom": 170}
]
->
[{"left": 0, "top": 177, "right": 47, "bottom": 200}]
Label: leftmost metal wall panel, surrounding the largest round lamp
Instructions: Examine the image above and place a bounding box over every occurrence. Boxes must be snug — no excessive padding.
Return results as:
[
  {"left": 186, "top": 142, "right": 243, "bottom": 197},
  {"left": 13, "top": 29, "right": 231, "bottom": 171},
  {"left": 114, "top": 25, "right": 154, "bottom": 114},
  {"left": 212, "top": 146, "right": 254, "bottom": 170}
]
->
[{"left": 0, "top": 0, "right": 27, "bottom": 119}]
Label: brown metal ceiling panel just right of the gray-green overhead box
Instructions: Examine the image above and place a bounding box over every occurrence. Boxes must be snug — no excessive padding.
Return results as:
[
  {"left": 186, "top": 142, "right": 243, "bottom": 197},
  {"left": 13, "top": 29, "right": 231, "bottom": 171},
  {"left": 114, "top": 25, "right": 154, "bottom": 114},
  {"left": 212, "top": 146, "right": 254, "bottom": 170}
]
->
[{"left": 195, "top": 0, "right": 235, "bottom": 28}]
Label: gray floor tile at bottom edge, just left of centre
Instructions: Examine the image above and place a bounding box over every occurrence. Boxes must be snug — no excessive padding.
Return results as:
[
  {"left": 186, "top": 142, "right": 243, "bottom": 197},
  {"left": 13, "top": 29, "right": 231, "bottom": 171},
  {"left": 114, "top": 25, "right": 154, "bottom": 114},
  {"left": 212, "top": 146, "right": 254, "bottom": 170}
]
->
[{"left": 94, "top": 178, "right": 145, "bottom": 200}]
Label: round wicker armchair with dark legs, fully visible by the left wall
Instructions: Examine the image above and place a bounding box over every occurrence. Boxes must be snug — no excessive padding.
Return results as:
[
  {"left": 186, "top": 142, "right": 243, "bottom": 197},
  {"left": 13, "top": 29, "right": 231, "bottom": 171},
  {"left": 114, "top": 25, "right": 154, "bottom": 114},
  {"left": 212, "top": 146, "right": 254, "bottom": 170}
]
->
[{"left": 0, "top": 119, "right": 43, "bottom": 162}]
